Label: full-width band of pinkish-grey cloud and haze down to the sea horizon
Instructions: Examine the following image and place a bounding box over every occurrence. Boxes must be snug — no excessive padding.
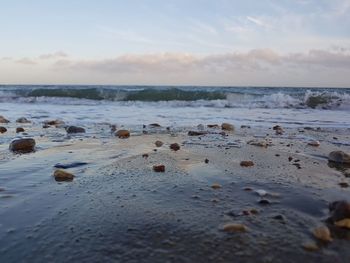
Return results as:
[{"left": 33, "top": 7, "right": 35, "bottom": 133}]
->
[{"left": 0, "top": 46, "right": 350, "bottom": 87}]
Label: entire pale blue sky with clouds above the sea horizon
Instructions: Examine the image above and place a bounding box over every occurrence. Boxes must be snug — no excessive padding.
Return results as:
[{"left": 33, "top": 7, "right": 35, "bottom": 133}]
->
[{"left": 0, "top": 0, "right": 350, "bottom": 87}]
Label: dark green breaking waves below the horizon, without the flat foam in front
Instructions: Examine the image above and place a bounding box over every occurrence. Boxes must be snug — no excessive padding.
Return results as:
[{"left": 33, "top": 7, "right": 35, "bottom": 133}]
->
[{"left": 0, "top": 86, "right": 350, "bottom": 110}]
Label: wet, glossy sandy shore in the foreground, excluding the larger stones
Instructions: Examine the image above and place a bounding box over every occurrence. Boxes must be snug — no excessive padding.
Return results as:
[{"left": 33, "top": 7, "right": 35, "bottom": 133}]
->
[{"left": 0, "top": 120, "right": 350, "bottom": 262}]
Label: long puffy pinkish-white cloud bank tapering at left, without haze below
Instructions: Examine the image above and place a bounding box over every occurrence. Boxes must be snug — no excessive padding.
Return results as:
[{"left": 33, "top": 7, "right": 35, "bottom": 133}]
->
[{"left": 54, "top": 49, "right": 350, "bottom": 74}]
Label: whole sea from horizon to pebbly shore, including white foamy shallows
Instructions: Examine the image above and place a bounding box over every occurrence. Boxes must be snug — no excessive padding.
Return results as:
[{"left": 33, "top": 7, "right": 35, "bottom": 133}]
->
[{"left": 0, "top": 85, "right": 350, "bottom": 128}]
